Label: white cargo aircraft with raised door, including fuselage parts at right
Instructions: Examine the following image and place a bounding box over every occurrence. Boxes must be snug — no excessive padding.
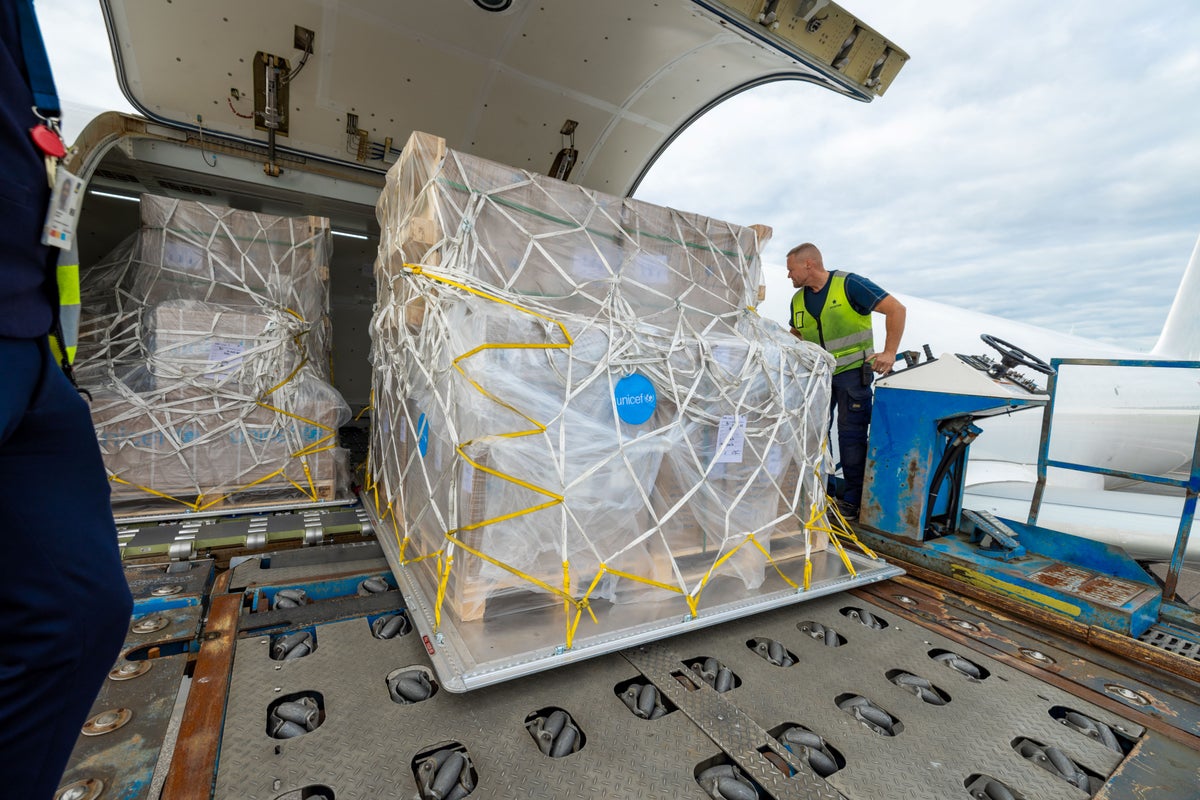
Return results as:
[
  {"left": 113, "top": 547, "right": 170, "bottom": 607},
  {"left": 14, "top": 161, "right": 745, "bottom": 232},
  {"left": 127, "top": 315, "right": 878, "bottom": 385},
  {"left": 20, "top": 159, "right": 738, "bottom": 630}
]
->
[{"left": 74, "top": 0, "right": 1200, "bottom": 558}]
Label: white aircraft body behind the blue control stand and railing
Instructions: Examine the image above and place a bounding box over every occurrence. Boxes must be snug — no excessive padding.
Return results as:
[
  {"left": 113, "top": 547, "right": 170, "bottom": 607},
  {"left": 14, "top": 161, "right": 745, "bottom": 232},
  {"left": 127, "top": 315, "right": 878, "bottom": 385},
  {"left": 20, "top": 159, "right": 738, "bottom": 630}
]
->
[{"left": 877, "top": 232, "right": 1200, "bottom": 563}]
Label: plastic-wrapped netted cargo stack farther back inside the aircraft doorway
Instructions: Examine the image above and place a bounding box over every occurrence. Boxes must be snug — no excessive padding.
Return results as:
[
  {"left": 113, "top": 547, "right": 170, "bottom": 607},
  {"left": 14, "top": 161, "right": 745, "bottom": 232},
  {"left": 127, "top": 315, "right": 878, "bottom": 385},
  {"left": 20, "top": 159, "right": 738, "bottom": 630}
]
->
[{"left": 76, "top": 194, "right": 349, "bottom": 513}]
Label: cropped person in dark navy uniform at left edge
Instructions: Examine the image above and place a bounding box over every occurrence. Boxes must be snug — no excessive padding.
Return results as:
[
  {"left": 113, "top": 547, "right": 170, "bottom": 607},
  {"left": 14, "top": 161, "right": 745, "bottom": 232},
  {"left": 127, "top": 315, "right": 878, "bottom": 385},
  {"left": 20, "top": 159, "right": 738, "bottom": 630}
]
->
[{"left": 0, "top": 0, "right": 132, "bottom": 800}]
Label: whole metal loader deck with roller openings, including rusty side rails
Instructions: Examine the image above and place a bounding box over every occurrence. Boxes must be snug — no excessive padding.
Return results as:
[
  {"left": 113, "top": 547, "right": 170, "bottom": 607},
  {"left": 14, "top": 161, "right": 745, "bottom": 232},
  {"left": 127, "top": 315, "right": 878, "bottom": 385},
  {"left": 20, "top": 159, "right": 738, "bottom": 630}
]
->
[{"left": 64, "top": 545, "right": 1200, "bottom": 800}]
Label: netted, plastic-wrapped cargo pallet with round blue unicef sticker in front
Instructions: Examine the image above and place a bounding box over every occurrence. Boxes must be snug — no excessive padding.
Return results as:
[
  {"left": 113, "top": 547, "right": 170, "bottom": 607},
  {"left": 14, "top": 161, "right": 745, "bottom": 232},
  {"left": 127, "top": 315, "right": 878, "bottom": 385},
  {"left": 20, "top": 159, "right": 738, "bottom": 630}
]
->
[{"left": 368, "top": 133, "right": 902, "bottom": 690}]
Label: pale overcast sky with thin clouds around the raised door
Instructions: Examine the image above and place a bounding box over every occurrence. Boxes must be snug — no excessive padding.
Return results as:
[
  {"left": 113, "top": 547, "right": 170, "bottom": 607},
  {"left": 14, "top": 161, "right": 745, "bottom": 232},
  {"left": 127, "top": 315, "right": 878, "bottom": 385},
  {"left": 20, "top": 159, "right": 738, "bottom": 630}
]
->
[{"left": 37, "top": 0, "right": 1200, "bottom": 348}]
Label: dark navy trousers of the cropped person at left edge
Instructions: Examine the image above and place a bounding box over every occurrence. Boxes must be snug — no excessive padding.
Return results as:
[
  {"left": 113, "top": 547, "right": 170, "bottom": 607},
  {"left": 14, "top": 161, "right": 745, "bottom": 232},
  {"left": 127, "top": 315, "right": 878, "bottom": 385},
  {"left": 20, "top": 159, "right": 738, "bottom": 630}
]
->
[{"left": 0, "top": 337, "right": 132, "bottom": 800}]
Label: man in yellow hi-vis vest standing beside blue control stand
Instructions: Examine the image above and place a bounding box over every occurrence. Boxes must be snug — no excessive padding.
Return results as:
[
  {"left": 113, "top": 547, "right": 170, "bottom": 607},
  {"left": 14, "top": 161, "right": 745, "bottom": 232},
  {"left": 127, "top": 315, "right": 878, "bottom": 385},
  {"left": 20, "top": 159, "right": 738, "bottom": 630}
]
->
[{"left": 787, "top": 242, "right": 905, "bottom": 519}]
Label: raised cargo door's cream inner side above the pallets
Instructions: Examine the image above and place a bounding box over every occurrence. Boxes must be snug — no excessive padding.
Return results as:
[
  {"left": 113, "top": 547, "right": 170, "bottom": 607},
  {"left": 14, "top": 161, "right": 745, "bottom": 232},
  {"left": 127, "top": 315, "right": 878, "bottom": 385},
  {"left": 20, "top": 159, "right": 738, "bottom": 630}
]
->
[{"left": 102, "top": 0, "right": 908, "bottom": 194}]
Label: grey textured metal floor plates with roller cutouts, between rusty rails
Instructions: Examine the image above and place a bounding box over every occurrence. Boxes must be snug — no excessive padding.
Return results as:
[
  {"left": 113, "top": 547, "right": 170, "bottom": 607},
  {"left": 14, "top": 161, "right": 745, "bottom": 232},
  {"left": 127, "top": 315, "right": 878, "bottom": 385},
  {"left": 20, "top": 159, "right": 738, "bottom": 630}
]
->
[{"left": 215, "top": 582, "right": 1200, "bottom": 800}]
